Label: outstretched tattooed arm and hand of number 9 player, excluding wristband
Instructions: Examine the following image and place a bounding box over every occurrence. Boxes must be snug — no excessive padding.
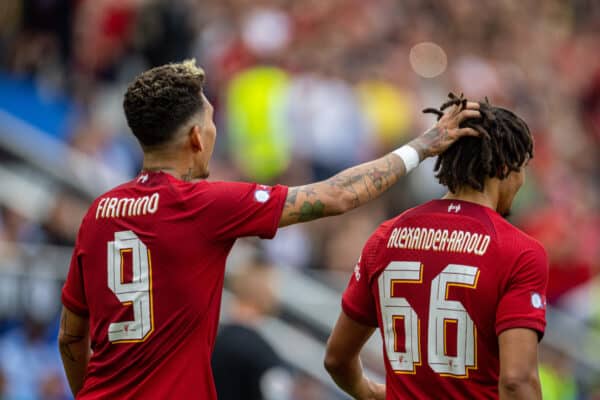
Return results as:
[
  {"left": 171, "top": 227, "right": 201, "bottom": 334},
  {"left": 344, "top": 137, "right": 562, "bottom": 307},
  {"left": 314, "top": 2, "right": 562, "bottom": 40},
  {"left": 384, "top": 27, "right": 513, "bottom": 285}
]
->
[{"left": 279, "top": 102, "right": 480, "bottom": 226}]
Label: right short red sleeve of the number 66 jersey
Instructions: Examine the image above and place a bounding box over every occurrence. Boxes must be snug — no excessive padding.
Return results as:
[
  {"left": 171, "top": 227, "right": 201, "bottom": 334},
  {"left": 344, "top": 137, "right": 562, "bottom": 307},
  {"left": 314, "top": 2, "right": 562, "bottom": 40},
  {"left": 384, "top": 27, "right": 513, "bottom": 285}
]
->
[{"left": 496, "top": 246, "right": 548, "bottom": 338}]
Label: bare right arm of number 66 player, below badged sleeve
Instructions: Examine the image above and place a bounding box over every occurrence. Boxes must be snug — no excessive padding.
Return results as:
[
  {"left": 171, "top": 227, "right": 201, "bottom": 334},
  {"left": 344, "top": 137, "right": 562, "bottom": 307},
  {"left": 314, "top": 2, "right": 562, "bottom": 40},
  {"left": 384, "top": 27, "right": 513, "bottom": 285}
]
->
[{"left": 498, "top": 328, "right": 542, "bottom": 400}]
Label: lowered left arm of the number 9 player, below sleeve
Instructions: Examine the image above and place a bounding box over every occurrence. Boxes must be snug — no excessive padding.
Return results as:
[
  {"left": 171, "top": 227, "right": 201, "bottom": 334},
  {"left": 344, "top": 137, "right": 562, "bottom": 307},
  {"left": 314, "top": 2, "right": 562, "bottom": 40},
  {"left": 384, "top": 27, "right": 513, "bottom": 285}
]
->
[{"left": 58, "top": 307, "right": 90, "bottom": 396}]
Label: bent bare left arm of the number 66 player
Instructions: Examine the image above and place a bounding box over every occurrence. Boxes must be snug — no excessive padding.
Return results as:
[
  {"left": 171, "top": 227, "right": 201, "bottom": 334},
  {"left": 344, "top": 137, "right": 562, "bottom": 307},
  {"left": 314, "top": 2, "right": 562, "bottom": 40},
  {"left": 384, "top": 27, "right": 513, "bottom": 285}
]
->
[{"left": 324, "top": 311, "right": 385, "bottom": 400}]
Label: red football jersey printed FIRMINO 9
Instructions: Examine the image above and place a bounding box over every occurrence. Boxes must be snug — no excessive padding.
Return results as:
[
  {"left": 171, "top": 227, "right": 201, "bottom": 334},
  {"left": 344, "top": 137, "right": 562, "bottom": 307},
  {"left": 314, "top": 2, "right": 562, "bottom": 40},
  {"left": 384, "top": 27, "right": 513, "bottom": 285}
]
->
[{"left": 62, "top": 172, "right": 287, "bottom": 400}]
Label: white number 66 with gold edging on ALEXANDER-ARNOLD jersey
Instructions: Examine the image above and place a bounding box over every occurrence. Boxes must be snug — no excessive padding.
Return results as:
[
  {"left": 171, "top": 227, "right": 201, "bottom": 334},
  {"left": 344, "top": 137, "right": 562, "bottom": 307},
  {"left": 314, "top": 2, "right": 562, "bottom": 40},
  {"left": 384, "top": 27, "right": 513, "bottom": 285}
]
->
[{"left": 378, "top": 261, "right": 479, "bottom": 378}]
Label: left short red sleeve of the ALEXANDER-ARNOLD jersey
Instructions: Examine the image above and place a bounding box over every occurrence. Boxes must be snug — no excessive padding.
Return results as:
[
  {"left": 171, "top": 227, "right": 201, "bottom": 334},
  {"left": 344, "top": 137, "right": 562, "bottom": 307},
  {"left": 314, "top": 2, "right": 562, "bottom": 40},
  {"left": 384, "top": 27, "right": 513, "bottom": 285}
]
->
[{"left": 342, "top": 238, "right": 378, "bottom": 326}]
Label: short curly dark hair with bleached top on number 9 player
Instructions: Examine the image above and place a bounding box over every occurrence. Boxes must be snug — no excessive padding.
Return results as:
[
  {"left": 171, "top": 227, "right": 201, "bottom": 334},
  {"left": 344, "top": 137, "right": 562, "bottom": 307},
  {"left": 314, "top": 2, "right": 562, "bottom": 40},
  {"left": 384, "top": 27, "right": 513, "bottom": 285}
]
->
[{"left": 123, "top": 59, "right": 204, "bottom": 148}]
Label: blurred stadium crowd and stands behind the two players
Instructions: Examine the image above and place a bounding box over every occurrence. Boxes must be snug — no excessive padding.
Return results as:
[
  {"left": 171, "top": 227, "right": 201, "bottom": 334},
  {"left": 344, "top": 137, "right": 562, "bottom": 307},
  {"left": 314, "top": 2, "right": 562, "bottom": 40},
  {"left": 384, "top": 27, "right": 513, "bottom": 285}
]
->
[{"left": 0, "top": 0, "right": 600, "bottom": 399}]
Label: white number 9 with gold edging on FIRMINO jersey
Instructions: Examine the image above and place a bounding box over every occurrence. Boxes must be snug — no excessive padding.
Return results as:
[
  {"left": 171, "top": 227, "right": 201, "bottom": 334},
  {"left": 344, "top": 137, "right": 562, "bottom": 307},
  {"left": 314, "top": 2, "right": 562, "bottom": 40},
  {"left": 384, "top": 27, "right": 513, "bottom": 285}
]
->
[{"left": 108, "top": 231, "right": 154, "bottom": 343}]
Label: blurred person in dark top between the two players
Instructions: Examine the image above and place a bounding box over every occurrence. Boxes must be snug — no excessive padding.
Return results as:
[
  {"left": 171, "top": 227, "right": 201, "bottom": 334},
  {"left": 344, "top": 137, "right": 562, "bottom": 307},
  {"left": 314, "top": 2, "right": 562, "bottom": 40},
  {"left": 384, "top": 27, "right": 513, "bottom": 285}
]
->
[{"left": 212, "top": 263, "right": 292, "bottom": 400}]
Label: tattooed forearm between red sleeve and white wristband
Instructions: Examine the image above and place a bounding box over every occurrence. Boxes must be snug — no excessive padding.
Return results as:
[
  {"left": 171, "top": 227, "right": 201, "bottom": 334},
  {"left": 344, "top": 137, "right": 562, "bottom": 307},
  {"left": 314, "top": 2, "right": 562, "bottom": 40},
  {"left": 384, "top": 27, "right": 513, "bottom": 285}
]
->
[{"left": 279, "top": 154, "right": 404, "bottom": 226}]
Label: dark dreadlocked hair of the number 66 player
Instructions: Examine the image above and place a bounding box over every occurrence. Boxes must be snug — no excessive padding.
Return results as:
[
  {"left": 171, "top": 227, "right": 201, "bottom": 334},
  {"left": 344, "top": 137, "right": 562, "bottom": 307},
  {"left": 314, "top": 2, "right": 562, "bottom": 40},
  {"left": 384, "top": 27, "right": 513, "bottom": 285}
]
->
[{"left": 423, "top": 93, "right": 533, "bottom": 193}]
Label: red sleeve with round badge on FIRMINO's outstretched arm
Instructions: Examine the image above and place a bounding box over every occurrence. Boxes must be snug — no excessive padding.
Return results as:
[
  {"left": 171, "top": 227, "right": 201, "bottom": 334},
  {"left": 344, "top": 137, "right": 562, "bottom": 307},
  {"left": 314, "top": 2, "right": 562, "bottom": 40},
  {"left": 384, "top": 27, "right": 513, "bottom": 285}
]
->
[{"left": 209, "top": 182, "right": 288, "bottom": 239}]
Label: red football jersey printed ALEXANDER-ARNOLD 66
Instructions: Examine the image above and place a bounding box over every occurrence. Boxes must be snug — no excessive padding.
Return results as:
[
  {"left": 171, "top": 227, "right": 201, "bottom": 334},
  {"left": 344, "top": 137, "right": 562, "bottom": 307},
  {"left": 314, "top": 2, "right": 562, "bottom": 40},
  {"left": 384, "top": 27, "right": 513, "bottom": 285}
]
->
[{"left": 342, "top": 200, "right": 548, "bottom": 399}]
